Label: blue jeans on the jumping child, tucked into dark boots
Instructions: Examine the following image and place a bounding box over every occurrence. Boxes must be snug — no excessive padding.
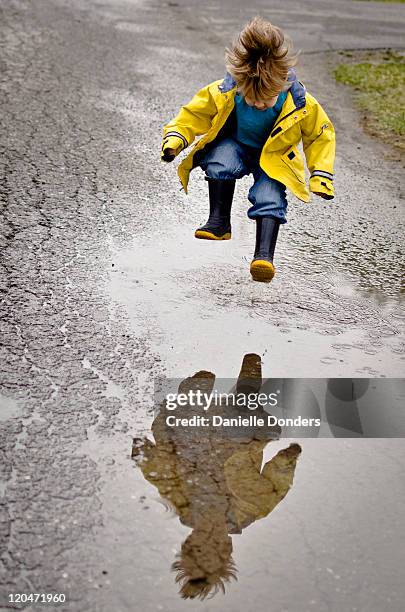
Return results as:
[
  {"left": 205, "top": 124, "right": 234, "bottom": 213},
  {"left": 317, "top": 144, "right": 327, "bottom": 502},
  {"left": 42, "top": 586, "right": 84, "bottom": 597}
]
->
[{"left": 196, "top": 138, "right": 287, "bottom": 223}]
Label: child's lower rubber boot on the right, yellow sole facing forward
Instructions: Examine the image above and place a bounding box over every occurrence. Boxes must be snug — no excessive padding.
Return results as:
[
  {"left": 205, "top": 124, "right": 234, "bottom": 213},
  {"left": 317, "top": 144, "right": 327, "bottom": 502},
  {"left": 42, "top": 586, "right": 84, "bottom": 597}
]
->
[{"left": 250, "top": 217, "right": 280, "bottom": 283}]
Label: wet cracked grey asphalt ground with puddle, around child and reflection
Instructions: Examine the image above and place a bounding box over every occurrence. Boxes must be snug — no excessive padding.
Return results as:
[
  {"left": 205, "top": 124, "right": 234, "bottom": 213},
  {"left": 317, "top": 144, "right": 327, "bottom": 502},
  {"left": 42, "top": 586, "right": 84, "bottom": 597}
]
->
[{"left": 0, "top": 0, "right": 405, "bottom": 612}]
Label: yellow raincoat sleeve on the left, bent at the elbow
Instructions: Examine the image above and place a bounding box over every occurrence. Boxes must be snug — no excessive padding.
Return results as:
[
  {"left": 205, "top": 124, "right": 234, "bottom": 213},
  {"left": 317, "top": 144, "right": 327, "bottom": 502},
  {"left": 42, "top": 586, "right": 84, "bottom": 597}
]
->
[{"left": 163, "top": 84, "right": 217, "bottom": 152}]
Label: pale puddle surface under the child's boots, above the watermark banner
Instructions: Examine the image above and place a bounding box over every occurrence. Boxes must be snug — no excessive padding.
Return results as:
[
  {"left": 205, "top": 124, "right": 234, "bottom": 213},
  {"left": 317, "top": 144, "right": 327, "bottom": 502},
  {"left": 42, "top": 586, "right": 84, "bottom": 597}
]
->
[{"left": 110, "top": 219, "right": 403, "bottom": 377}]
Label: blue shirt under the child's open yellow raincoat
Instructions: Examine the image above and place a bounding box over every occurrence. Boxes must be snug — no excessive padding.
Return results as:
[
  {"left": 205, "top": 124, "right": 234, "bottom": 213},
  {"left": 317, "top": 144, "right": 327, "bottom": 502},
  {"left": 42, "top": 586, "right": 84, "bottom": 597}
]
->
[{"left": 234, "top": 91, "right": 288, "bottom": 149}]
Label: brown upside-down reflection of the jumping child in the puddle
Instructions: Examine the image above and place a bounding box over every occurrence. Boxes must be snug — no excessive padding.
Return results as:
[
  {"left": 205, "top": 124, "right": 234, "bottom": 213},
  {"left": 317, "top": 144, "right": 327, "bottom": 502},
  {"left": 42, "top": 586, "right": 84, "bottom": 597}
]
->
[{"left": 132, "top": 354, "right": 301, "bottom": 599}]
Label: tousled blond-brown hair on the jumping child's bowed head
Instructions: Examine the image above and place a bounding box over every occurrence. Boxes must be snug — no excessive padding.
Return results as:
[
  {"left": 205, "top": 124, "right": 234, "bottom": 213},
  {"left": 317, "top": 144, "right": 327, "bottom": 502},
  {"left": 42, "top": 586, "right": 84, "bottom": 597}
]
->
[{"left": 225, "top": 17, "right": 297, "bottom": 100}]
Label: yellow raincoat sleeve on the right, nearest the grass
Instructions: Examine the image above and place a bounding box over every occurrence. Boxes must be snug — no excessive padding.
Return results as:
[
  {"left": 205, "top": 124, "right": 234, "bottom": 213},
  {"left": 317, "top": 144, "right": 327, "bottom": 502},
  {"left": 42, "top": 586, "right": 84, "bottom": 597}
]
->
[{"left": 301, "top": 99, "right": 336, "bottom": 200}]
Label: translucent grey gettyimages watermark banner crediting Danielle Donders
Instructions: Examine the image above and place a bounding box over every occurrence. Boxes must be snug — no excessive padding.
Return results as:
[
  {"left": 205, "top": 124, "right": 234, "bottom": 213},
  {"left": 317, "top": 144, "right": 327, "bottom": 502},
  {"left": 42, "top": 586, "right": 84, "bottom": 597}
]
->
[{"left": 155, "top": 378, "right": 405, "bottom": 438}]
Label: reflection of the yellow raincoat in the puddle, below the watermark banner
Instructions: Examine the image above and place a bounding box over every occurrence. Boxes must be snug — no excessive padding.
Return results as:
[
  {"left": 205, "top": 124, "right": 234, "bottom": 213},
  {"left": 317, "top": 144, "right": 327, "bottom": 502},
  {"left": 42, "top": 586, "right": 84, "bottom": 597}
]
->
[{"left": 133, "top": 432, "right": 301, "bottom": 533}]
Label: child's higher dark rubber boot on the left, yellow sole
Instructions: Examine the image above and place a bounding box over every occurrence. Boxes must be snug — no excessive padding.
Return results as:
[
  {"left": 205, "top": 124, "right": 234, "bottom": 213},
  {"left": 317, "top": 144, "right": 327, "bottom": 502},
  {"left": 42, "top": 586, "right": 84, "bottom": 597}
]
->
[{"left": 195, "top": 179, "right": 235, "bottom": 240}]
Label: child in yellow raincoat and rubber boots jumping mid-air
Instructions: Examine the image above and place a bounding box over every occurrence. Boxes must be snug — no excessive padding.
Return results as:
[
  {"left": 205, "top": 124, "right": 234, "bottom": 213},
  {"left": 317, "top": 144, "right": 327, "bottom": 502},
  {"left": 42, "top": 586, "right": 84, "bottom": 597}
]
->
[{"left": 162, "top": 17, "right": 335, "bottom": 282}]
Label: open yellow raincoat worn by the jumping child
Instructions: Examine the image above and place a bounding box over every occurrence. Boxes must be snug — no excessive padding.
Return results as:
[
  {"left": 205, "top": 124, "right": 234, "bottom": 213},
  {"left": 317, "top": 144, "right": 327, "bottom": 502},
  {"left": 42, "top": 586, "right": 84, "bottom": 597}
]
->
[{"left": 163, "top": 73, "right": 335, "bottom": 202}]
